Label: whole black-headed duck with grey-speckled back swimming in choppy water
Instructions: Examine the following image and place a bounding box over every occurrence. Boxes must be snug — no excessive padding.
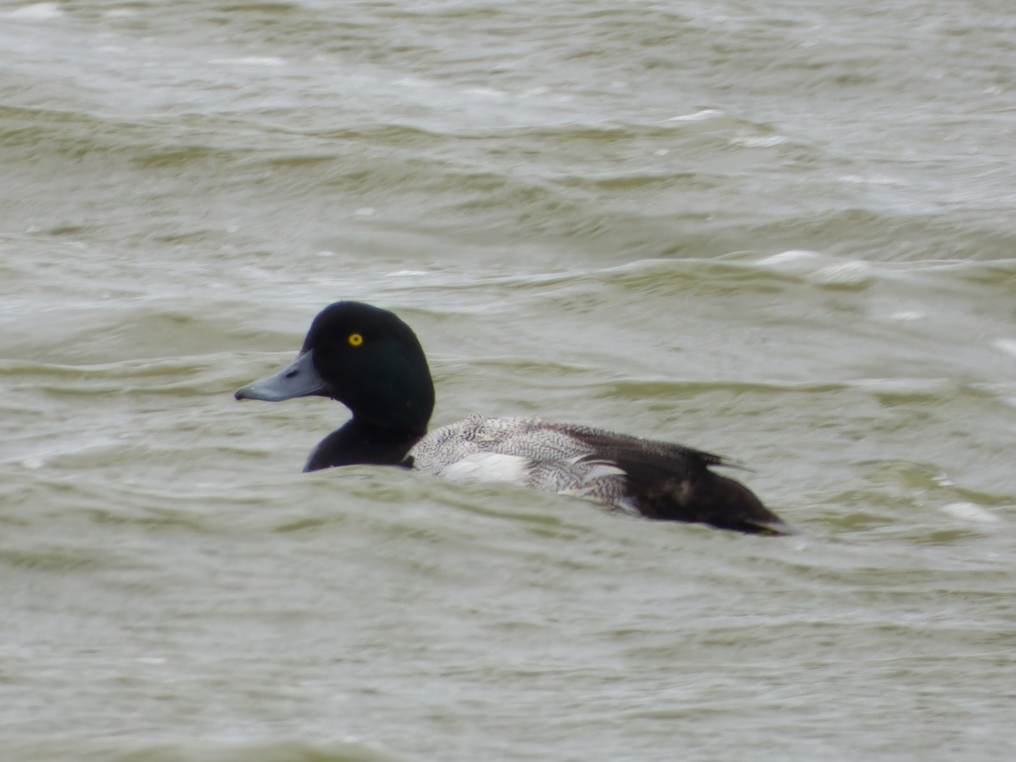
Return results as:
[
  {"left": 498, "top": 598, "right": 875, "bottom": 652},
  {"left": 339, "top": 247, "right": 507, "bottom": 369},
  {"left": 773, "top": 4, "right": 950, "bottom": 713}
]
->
[{"left": 234, "top": 301, "right": 793, "bottom": 535}]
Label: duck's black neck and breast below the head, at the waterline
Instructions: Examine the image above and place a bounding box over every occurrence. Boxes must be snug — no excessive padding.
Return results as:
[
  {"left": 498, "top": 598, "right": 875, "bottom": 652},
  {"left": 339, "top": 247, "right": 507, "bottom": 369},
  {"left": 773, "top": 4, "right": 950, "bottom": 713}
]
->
[{"left": 304, "top": 416, "right": 427, "bottom": 471}]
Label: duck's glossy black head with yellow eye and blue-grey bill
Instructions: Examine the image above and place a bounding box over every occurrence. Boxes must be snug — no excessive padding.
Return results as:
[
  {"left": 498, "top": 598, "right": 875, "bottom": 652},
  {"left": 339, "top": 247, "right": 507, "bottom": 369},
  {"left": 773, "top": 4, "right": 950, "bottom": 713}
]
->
[{"left": 235, "top": 302, "right": 434, "bottom": 434}]
